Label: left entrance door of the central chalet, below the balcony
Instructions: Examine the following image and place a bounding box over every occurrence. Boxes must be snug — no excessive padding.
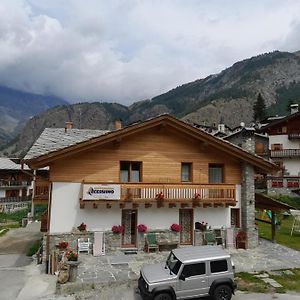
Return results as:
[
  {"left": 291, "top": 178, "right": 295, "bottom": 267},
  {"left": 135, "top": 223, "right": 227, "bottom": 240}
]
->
[{"left": 122, "top": 209, "right": 137, "bottom": 247}]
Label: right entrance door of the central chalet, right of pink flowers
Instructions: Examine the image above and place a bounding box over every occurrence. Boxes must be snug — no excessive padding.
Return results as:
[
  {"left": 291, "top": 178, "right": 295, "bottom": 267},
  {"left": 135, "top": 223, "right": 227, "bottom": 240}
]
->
[{"left": 179, "top": 209, "right": 194, "bottom": 245}]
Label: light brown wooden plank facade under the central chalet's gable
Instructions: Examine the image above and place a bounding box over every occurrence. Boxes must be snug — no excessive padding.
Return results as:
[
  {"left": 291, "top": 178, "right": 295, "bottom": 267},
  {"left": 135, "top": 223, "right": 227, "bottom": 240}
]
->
[{"left": 50, "top": 128, "right": 241, "bottom": 184}]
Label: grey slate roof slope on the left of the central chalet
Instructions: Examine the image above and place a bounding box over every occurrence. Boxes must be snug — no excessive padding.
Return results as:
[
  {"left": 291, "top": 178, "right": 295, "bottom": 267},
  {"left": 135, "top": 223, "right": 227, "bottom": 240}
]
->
[{"left": 24, "top": 128, "right": 110, "bottom": 160}]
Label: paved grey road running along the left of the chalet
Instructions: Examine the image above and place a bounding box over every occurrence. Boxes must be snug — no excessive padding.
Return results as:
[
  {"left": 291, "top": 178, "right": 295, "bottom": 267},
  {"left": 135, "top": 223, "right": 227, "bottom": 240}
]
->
[{"left": 0, "top": 223, "right": 41, "bottom": 300}]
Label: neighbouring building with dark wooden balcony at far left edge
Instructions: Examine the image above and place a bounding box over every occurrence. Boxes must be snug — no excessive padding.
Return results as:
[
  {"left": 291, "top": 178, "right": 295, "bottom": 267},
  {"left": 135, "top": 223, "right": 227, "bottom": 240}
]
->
[{"left": 0, "top": 157, "right": 33, "bottom": 212}]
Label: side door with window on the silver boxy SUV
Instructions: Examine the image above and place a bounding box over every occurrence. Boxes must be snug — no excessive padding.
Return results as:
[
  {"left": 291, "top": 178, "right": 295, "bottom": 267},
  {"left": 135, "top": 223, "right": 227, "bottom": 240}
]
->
[{"left": 176, "top": 262, "right": 209, "bottom": 299}]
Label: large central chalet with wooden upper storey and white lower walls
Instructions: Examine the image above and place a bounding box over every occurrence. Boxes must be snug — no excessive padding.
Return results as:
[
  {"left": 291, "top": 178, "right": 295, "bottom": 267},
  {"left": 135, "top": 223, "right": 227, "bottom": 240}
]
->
[{"left": 24, "top": 115, "right": 274, "bottom": 253}]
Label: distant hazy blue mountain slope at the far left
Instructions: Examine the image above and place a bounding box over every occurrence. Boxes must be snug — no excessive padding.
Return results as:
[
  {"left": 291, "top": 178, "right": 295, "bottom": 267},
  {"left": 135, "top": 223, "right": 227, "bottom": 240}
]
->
[{"left": 0, "top": 86, "right": 67, "bottom": 148}]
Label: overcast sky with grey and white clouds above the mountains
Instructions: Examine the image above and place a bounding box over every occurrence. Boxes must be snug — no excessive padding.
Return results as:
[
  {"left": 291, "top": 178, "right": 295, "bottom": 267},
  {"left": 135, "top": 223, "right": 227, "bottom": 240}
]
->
[{"left": 0, "top": 0, "right": 300, "bottom": 104}]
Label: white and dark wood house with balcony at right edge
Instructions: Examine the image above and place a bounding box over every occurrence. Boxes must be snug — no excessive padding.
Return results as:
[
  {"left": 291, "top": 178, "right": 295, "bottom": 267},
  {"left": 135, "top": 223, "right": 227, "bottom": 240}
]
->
[{"left": 260, "top": 105, "right": 300, "bottom": 194}]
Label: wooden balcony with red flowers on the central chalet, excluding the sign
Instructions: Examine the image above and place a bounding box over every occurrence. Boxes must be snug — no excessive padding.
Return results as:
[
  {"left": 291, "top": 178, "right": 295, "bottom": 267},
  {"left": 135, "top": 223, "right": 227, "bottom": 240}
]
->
[{"left": 80, "top": 183, "right": 236, "bottom": 208}]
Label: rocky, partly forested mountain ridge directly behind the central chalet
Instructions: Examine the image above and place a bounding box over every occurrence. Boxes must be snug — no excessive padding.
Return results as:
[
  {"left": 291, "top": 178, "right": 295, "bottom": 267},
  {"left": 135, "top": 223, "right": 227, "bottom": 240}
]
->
[{"left": 2, "top": 51, "right": 300, "bottom": 154}]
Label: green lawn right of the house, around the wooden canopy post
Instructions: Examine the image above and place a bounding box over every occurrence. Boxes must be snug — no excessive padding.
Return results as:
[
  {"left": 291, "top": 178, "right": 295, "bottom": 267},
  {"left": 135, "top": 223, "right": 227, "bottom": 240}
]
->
[{"left": 257, "top": 216, "right": 300, "bottom": 251}]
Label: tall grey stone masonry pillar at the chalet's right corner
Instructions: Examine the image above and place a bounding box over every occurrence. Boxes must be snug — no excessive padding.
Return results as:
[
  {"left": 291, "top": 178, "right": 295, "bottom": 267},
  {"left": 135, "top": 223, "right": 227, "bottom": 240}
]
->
[{"left": 241, "top": 163, "right": 258, "bottom": 249}]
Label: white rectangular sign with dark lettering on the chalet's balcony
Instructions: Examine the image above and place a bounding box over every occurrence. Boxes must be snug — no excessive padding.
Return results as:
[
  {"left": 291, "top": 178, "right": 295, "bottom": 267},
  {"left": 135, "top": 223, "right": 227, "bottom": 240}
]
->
[{"left": 83, "top": 184, "right": 121, "bottom": 200}]
